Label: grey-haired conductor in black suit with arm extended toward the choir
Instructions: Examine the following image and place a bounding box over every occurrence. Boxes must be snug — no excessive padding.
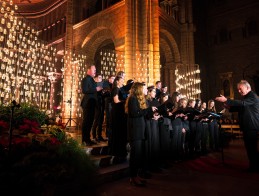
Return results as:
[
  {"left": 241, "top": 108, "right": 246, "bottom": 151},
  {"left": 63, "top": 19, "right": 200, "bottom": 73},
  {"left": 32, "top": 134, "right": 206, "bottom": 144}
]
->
[{"left": 215, "top": 80, "right": 259, "bottom": 172}]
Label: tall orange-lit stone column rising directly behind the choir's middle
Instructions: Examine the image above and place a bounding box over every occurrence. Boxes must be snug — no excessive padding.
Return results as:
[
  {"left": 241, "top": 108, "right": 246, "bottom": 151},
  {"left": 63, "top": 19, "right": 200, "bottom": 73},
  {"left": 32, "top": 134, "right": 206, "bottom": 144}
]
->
[{"left": 125, "top": 0, "right": 160, "bottom": 83}]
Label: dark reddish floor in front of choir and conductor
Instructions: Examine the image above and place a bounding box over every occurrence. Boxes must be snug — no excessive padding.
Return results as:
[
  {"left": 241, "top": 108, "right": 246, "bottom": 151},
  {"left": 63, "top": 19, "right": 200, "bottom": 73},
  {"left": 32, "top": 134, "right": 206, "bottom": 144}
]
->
[{"left": 94, "top": 139, "right": 259, "bottom": 196}]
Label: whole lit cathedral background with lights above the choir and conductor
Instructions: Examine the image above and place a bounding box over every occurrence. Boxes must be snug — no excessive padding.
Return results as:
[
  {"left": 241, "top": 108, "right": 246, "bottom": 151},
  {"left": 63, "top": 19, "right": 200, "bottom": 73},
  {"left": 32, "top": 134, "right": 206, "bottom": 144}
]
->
[{"left": 0, "top": 0, "right": 259, "bottom": 121}]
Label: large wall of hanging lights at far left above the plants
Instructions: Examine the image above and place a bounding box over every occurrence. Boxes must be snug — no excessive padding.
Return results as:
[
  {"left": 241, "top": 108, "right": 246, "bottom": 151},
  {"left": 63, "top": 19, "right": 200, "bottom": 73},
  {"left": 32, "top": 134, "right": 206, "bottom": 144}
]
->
[{"left": 0, "top": 0, "right": 57, "bottom": 110}]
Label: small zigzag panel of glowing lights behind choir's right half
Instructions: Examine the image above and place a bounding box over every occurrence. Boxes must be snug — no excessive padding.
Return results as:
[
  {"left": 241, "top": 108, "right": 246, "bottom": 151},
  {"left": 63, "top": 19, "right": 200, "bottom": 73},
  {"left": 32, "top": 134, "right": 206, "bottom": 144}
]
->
[{"left": 175, "top": 64, "right": 201, "bottom": 99}]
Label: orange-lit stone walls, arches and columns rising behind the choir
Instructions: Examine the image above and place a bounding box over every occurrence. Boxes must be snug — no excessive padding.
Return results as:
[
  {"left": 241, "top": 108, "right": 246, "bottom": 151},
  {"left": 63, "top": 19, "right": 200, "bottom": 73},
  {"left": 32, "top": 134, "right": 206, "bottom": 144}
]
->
[{"left": 6, "top": 0, "right": 199, "bottom": 121}]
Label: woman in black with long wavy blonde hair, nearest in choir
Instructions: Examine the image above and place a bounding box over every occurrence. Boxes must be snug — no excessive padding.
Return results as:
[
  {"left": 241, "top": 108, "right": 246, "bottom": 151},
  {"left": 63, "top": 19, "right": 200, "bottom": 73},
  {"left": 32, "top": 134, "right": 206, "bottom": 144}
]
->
[{"left": 125, "top": 82, "right": 156, "bottom": 186}]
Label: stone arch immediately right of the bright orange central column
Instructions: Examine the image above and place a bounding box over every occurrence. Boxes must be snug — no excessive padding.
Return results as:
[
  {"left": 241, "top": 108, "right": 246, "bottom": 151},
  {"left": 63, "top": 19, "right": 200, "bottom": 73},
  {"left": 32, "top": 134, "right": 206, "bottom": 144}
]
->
[{"left": 160, "top": 29, "right": 181, "bottom": 93}]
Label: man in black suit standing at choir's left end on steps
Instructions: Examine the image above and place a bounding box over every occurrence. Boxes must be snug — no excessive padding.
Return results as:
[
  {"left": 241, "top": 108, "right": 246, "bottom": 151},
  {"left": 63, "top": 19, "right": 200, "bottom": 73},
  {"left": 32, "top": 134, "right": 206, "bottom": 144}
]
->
[{"left": 81, "top": 65, "right": 102, "bottom": 146}]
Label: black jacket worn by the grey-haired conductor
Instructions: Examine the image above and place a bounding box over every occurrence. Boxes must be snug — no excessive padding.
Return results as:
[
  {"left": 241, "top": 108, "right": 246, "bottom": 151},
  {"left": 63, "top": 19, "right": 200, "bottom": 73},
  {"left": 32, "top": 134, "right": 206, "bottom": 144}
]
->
[{"left": 227, "top": 91, "right": 259, "bottom": 131}]
